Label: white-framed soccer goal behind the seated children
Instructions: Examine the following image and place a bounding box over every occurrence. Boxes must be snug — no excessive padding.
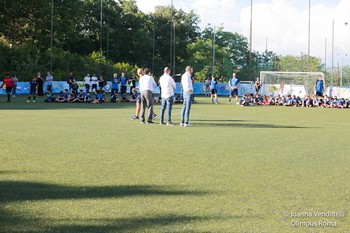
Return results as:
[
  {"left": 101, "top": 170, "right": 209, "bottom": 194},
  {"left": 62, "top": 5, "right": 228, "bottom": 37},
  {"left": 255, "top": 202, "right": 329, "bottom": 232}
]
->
[{"left": 260, "top": 71, "right": 324, "bottom": 97}]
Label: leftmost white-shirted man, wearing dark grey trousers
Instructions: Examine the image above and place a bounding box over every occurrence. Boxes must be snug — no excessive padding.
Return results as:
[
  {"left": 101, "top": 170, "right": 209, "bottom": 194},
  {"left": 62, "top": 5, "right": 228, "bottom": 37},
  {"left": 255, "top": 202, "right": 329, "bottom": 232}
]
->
[{"left": 139, "top": 68, "right": 156, "bottom": 124}]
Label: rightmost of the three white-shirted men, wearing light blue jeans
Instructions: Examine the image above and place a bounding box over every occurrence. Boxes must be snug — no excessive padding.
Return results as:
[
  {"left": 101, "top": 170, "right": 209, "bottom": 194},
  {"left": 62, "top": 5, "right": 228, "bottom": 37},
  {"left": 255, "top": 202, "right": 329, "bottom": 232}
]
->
[{"left": 180, "top": 66, "right": 193, "bottom": 127}]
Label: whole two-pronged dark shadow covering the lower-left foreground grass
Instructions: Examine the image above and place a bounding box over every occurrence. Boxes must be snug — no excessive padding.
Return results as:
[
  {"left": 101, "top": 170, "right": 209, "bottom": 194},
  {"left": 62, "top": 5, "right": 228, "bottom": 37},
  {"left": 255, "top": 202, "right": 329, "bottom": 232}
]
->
[{"left": 0, "top": 181, "right": 221, "bottom": 233}]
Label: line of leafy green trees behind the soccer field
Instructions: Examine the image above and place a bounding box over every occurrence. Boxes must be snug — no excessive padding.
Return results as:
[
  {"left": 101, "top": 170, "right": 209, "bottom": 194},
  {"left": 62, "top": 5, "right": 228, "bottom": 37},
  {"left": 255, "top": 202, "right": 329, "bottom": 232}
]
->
[{"left": 0, "top": 0, "right": 330, "bottom": 81}]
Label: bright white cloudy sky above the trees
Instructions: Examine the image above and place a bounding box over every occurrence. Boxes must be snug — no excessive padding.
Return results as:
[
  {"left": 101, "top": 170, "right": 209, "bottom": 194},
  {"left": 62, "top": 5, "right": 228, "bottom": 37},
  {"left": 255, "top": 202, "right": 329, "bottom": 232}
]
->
[{"left": 137, "top": 0, "right": 350, "bottom": 67}]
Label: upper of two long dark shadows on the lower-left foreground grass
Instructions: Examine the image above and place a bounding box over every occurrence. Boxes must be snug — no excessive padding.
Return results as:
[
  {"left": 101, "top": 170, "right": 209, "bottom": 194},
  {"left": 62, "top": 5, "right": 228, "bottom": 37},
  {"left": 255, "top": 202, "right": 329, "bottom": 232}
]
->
[{"left": 0, "top": 181, "right": 207, "bottom": 203}]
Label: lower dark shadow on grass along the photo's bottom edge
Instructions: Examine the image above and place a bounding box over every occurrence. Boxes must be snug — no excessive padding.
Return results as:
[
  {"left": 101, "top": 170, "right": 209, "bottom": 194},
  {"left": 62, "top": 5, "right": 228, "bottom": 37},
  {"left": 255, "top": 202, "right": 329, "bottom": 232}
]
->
[{"left": 0, "top": 206, "right": 223, "bottom": 233}]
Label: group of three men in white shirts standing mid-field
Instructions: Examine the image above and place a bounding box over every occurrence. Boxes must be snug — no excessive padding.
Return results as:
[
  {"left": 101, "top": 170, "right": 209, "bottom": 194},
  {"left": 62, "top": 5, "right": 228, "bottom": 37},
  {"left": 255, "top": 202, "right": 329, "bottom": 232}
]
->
[{"left": 139, "top": 66, "right": 194, "bottom": 127}]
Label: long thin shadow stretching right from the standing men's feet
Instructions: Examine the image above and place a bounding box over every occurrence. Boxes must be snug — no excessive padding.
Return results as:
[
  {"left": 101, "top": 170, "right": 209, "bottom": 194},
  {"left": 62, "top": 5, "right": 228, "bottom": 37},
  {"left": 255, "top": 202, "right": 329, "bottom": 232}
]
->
[{"left": 193, "top": 120, "right": 310, "bottom": 129}]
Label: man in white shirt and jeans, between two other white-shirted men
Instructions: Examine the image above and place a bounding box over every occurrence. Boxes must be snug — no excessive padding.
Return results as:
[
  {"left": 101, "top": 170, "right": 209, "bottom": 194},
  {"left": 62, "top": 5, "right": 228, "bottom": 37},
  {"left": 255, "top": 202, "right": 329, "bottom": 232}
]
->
[{"left": 159, "top": 67, "right": 176, "bottom": 126}]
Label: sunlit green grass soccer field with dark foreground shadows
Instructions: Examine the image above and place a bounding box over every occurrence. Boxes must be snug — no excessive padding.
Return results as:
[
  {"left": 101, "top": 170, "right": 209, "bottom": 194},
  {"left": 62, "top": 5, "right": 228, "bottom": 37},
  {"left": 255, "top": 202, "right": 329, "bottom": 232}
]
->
[{"left": 0, "top": 96, "right": 350, "bottom": 232}]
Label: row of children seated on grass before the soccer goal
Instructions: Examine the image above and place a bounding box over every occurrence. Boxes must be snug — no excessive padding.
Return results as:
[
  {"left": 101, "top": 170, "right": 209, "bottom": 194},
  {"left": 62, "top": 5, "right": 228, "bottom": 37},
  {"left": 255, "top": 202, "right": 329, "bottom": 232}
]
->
[{"left": 239, "top": 94, "right": 350, "bottom": 108}]
